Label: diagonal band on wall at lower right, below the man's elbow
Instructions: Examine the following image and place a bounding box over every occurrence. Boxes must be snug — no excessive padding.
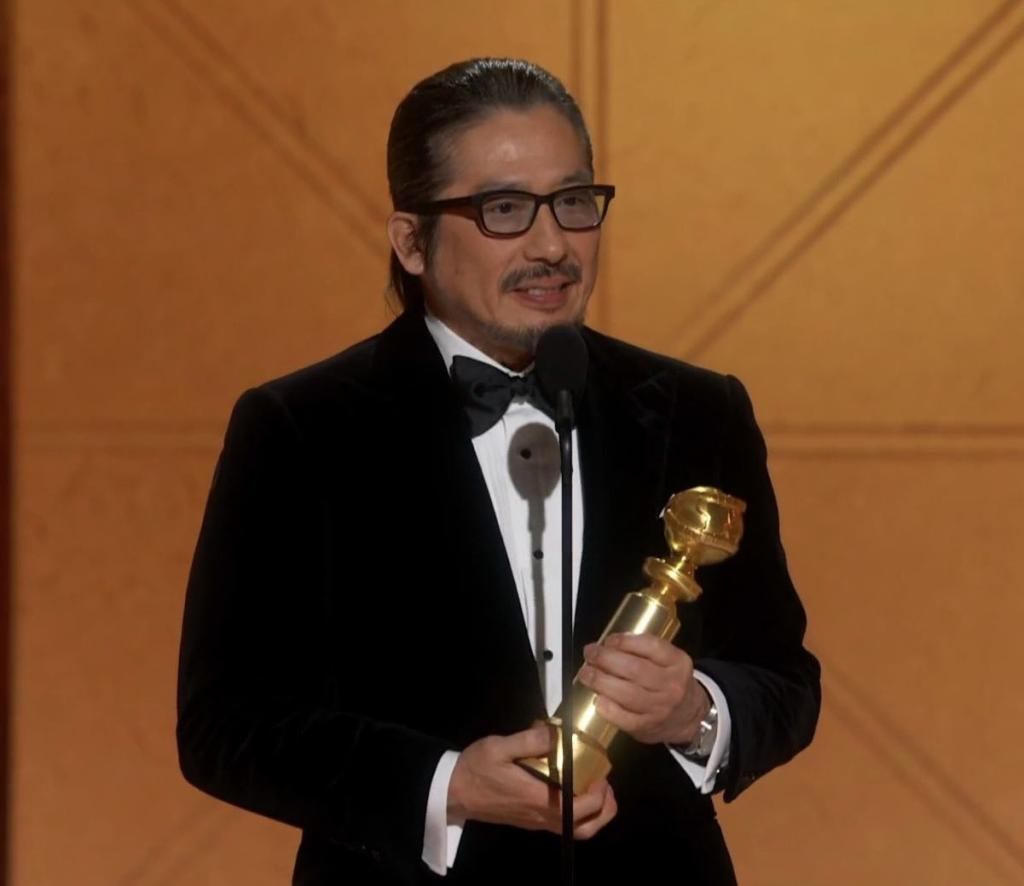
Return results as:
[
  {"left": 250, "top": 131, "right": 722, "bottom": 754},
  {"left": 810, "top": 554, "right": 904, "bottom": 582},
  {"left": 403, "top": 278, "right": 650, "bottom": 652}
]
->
[{"left": 822, "top": 660, "right": 1024, "bottom": 884}]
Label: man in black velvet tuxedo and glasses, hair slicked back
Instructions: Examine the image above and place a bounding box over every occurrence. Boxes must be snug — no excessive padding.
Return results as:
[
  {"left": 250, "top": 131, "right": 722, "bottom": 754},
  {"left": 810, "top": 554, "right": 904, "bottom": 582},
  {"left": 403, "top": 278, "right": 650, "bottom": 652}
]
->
[{"left": 178, "top": 59, "right": 820, "bottom": 884}]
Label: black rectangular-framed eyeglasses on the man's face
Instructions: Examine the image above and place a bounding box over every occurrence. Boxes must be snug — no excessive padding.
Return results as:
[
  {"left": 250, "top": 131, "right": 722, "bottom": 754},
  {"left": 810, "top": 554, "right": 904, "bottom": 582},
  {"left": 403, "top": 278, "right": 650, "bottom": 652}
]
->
[{"left": 402, "top": 184, "right": 615, "bottom": 237}]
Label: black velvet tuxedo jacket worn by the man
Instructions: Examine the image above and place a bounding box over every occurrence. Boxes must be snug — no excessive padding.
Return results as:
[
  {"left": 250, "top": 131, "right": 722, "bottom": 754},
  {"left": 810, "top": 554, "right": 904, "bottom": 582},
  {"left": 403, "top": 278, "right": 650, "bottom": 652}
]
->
[{"left": 177, "top": 313, "right": 820, "bottom": 886}]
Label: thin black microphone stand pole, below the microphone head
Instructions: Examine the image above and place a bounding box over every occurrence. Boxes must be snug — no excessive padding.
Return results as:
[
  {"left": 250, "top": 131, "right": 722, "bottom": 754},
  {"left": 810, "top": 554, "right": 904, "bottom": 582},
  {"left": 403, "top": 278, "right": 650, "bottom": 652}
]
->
[{"left": 555, "top": 389, "right": 575, "bottom": 886}]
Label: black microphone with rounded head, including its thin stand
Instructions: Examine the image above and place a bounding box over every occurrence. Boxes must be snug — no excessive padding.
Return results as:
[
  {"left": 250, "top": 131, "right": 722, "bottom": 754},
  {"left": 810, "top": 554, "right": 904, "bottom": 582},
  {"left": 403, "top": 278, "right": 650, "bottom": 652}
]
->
[{"left": 534, "top": 326, "right": 588, "bottom": 886}]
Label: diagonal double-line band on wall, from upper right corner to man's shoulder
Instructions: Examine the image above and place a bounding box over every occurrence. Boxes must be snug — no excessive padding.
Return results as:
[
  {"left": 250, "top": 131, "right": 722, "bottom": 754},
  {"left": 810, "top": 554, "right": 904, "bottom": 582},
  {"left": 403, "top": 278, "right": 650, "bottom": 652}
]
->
[{"left": 668, "top": 0, "right": 1024, "bottom": 360}]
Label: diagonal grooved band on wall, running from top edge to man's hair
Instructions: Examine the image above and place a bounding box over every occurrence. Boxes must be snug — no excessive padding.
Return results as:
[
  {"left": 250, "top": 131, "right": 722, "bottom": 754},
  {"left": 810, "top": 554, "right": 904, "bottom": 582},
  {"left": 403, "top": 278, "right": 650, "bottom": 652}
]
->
[{"left": 129, "top": 0, "right": 388, "bottom": 258}]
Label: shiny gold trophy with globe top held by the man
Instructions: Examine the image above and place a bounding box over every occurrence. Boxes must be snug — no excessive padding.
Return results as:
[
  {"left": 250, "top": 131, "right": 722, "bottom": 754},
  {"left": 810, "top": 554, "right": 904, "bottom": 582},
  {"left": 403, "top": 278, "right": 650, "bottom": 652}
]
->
[{"left": 518, "top": 487, "right": 746, "bottom": 794}]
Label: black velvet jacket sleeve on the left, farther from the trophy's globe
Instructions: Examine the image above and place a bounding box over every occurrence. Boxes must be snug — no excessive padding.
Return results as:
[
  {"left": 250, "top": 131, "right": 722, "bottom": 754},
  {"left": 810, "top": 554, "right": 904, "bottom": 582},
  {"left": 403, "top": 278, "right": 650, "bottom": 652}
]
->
[{"left": 177, "top": 388, "right": 447, "bottom": 863}]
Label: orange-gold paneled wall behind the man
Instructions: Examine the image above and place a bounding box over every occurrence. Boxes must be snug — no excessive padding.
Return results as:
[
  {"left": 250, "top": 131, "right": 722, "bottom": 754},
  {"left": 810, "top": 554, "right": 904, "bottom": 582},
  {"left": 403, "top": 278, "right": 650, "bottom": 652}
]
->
[{"left": 11, "top": 0, "right": 1024, "bottom": 886}]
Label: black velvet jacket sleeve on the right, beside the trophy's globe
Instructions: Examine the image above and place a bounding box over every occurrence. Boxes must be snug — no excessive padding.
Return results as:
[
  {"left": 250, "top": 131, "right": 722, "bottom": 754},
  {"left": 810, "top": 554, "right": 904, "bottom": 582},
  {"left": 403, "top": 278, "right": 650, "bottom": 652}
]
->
[{"left": 695, "top": 376, "right": 821, "bottom": 801}]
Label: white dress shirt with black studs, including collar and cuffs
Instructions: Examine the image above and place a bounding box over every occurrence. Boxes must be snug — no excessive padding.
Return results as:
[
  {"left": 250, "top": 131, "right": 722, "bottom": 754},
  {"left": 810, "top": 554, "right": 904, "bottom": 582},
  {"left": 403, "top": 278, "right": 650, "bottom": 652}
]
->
[{"left": 415, "top": 313, "right": 731, "bottom": 876}]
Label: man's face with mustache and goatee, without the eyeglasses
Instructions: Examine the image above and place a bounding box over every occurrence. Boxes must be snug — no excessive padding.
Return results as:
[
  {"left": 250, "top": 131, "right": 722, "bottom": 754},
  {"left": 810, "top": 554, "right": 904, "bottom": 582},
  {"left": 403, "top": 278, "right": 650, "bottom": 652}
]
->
[{"left": 422, "top": 106, "right": 600, "bottom": 369}]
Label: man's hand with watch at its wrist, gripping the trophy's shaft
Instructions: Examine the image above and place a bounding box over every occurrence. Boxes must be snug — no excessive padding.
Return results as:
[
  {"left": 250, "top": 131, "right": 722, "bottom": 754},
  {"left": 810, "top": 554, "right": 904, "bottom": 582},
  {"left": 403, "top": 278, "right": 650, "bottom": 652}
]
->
[{"left": 580, "top": 634, "right": 711, "bottom": 745}]
